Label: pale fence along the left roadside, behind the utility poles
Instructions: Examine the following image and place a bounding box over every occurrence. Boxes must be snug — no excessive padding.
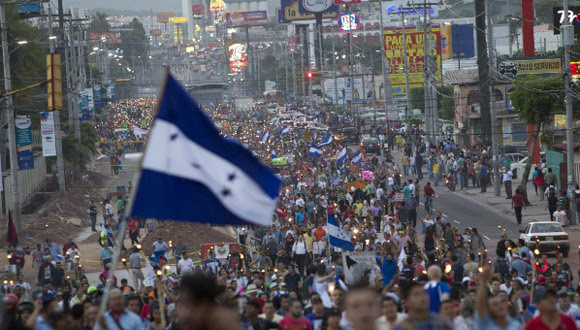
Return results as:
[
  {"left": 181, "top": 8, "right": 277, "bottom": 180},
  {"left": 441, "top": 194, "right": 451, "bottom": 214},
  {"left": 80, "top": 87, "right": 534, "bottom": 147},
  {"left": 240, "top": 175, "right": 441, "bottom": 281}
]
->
[{"left": 0, "top": 156, "right": 46, "bottom": 216}]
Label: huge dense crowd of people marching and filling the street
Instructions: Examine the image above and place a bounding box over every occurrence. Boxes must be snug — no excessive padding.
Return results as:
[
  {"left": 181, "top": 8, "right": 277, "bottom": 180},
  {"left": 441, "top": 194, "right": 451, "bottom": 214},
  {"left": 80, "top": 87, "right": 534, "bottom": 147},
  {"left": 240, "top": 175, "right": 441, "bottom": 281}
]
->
[{"left": 2, "top": 97, "right": 580, "bottom": 330}]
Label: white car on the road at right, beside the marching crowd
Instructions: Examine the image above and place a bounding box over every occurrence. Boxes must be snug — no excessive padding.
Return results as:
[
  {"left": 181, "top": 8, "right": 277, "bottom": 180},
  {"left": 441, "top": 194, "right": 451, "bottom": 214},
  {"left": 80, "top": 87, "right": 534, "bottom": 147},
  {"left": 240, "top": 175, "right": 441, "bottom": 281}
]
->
[{"left": 520, "top": 221, "right": 570, "bottom": 257}]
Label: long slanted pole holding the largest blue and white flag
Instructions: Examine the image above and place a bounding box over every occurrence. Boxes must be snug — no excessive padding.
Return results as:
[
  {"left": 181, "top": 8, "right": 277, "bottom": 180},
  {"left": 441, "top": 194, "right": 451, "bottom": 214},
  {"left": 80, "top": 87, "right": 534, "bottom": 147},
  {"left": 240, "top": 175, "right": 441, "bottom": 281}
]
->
[{"left": 97, "top": 69, "right": 169, "bottom": 329}]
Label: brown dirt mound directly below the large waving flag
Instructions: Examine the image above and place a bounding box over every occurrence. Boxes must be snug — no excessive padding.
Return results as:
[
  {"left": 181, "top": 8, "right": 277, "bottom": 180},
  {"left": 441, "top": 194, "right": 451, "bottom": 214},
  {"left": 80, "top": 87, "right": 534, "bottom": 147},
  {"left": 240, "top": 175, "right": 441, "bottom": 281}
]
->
[{"left": 136, "top": 221, "right": 235, "bottom": 255}]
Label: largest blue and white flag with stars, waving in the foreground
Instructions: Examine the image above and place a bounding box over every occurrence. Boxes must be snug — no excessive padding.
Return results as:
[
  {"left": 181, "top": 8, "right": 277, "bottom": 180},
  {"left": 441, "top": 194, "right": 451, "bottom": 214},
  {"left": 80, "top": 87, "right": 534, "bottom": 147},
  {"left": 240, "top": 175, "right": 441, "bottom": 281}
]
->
[{"left": 130, "top": 74, "right": 281, "bottom": 226}]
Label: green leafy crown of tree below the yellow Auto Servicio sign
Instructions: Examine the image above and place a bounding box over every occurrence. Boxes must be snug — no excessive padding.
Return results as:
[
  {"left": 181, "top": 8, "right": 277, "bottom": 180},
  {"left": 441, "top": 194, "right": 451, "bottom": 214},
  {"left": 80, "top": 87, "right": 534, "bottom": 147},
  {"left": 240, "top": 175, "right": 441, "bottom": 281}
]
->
[{"left": 510, "top": 76, "right": 564, "bottom": 126}]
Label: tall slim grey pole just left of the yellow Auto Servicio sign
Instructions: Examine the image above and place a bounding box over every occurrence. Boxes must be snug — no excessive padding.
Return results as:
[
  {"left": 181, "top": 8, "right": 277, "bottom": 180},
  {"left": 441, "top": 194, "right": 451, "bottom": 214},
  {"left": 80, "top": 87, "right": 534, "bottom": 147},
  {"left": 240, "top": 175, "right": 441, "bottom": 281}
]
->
[{"left": 488, "top": 0, "right": 501, "bottom": 196}]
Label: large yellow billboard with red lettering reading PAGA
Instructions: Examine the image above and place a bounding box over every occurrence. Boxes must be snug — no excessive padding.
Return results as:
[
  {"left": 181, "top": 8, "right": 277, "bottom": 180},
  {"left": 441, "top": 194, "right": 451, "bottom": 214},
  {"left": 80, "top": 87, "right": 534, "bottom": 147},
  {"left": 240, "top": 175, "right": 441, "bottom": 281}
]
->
[{"left": 383, "top": 26, "right": 441, "bottom": 95}]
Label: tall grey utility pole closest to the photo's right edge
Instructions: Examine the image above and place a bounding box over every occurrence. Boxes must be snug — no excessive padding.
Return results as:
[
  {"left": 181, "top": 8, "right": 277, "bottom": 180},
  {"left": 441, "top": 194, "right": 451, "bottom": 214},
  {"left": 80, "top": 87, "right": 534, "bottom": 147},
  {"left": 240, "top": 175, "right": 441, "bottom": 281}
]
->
[{"left": 562, "top": 0, "right": 578, "bottom": 225}]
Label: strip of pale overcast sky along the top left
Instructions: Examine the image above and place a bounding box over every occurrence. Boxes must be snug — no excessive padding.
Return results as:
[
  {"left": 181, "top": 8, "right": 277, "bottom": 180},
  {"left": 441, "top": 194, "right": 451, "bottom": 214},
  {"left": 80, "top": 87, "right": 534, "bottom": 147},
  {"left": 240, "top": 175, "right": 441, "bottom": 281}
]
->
[{"left": 63, "top": 0, "right": 181, "bottom": 12}]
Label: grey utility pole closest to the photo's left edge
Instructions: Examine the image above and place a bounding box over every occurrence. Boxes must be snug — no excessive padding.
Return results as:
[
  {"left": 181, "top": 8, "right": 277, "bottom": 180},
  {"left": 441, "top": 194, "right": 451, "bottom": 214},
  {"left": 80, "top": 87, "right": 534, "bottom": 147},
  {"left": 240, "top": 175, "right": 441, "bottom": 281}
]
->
[{"left": 0, "top": 2, "right": 22, "bottom": 232}]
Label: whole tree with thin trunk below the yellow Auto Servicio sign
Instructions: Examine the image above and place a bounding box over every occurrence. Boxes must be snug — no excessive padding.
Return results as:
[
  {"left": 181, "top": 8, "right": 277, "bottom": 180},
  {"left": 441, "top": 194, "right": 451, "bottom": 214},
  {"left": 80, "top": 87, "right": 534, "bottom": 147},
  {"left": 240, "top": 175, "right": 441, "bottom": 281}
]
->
[{"left": 510, "top": 76, "right": 564, "bottom": 205}]
